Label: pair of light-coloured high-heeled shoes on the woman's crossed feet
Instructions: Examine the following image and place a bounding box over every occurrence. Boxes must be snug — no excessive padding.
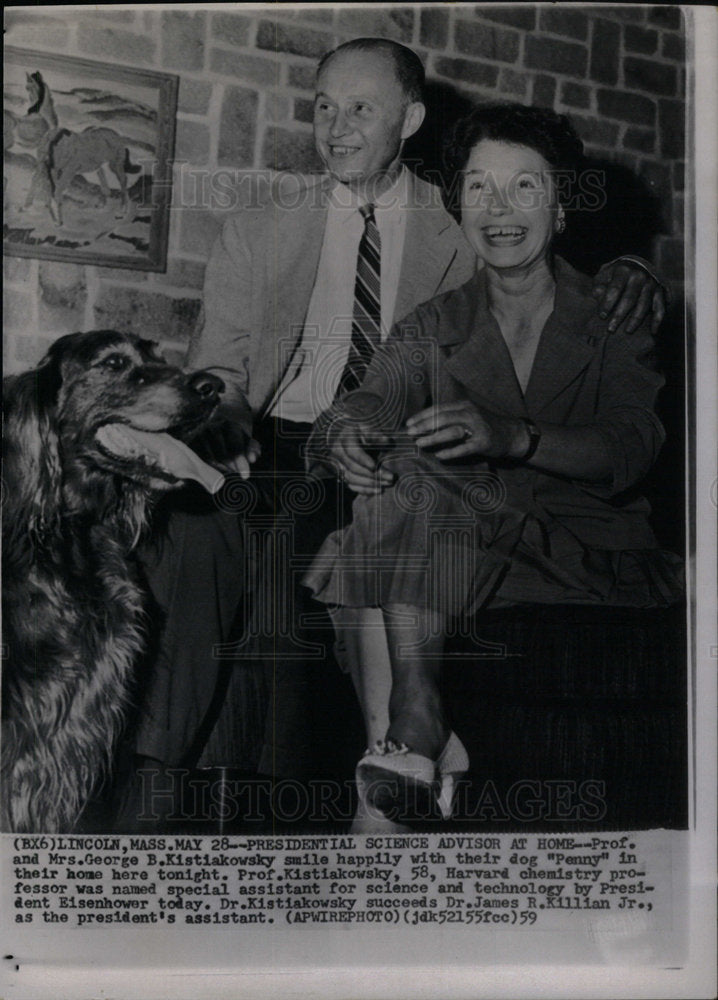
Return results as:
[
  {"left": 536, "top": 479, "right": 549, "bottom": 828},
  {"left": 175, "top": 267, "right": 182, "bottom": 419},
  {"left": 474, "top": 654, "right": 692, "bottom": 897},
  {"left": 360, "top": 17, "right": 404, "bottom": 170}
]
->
[{"left": 356, "top": 732, "right": 469, "bottom": 820}]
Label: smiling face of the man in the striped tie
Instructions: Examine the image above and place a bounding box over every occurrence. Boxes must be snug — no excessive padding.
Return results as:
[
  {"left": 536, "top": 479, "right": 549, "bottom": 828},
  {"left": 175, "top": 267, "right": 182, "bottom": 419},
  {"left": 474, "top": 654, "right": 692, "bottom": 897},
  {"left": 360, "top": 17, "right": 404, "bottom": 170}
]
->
[{"left": 314, "top": 52, "right": 423, "bottom": 195}]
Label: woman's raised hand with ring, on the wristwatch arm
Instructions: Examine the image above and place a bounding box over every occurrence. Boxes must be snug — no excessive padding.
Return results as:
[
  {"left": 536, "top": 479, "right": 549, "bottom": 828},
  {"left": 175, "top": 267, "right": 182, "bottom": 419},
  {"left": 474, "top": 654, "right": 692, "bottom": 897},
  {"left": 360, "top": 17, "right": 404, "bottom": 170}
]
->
[{"left": 406, "top": 400, "right": 529, "bottom": 461}]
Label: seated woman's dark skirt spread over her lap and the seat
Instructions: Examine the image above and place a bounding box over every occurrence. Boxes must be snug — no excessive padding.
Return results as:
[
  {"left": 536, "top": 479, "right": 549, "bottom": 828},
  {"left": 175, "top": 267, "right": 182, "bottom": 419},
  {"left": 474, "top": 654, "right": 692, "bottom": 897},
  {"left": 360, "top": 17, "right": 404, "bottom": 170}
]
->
[{"left": 303, "top": 454, "right": 682, "bottom": 617}]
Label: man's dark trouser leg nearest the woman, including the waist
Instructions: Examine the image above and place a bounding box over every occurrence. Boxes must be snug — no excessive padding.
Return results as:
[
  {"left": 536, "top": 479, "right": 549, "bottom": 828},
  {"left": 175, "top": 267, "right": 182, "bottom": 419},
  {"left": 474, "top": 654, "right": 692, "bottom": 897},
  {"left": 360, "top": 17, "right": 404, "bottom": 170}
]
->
[{"left": 252, "top": 419, "right": 361, "bottom": 780}]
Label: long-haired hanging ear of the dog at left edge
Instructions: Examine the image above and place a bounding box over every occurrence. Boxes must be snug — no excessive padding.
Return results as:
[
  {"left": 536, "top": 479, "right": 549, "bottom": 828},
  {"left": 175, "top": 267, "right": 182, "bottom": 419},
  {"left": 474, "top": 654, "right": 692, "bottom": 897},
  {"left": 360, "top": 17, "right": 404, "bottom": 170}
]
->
[{"left": 3, "top": 354, "right": 61, "bottom": 537}]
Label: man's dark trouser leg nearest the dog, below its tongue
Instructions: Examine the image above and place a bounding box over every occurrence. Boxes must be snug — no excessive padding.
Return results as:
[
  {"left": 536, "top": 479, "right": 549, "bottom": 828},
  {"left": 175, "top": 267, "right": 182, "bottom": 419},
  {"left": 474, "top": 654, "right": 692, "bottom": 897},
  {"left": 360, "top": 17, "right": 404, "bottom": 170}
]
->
[{"left": 134, "top": 487, "right": 248, "bottom": 766}]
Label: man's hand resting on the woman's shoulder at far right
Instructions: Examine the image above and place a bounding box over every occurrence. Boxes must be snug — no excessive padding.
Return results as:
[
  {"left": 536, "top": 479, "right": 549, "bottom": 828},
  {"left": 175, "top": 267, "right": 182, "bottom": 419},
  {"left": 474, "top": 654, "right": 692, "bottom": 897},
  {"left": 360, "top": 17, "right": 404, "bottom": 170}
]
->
[{"left": 593, "top": 259, "right": 666, "bottom": 334}]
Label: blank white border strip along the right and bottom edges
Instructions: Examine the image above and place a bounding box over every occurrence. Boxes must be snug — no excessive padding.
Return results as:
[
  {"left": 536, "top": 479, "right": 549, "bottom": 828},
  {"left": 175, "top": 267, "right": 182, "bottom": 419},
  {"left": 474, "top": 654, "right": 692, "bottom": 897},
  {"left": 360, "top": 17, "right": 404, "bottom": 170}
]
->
[{"left": 0, "top": 5, "right": 718, "bottom": 1000}]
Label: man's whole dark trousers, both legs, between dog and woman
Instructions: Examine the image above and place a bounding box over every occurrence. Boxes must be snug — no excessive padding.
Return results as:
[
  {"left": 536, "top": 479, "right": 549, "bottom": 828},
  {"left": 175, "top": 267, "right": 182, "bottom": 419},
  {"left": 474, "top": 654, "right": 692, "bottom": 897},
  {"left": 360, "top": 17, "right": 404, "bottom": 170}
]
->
[{"left": 127, "top": 419, "right": 358, "bottom": 780}]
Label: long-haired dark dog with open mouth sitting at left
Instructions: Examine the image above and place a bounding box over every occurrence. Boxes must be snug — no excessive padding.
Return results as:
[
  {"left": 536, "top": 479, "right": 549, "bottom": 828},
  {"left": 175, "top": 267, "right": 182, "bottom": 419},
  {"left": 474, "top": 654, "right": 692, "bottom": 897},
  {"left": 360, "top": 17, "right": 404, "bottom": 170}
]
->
[{"left": 2, "top": 330, "right": 223, "bottom": 832}]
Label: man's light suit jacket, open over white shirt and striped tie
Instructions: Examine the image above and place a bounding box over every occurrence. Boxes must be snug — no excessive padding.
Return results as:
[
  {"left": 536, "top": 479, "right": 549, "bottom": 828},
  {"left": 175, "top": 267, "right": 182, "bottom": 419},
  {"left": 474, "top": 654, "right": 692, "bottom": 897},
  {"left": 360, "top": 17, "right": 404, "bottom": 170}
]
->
[{"left": 188, "top": 172, "right": 476, "bottom": 430}]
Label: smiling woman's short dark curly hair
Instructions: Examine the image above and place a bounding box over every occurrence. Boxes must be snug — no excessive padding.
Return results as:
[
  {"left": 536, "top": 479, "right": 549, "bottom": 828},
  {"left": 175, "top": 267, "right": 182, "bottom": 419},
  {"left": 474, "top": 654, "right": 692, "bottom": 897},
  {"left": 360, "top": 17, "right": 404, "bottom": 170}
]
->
[{"left": 444, "top": 104, "right": 583, "bottom": 218}]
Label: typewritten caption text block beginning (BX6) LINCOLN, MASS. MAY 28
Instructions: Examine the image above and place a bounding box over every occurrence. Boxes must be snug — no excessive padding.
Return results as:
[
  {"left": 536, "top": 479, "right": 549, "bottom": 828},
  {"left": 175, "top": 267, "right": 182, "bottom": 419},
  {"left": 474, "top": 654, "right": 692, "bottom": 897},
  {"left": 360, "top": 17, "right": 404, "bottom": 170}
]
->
[{"left": 9, "top": 833, "right": 661, "bottom": 930}]
